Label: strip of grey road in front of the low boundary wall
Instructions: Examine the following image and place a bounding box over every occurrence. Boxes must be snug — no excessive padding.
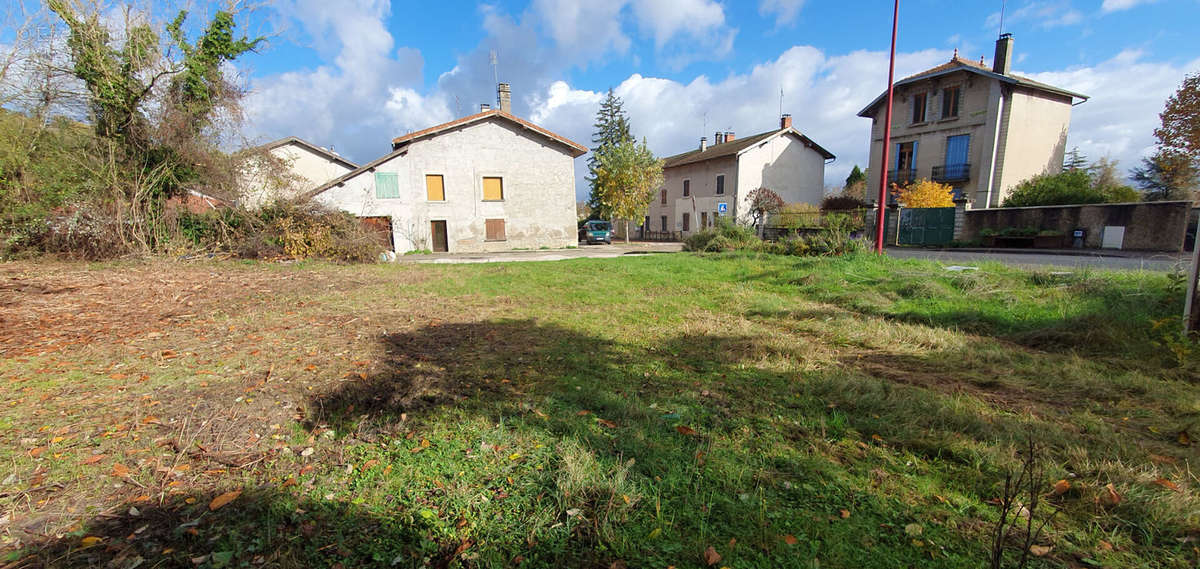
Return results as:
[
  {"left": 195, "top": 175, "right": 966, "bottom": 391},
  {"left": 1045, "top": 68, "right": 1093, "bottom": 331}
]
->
[{"left": 887, "top": 247, "right": 1189, "bottom": 271}]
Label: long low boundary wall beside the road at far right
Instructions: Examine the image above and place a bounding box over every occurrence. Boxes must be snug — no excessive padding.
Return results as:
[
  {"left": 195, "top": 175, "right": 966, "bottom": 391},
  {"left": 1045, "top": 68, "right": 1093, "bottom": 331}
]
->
[{"left": 956, "top": 202, "right": 1192, "bottom": 251}]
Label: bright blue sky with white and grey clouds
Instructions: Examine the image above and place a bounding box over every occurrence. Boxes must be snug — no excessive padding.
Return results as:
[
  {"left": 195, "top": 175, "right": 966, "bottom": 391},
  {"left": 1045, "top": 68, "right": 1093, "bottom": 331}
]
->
[{"left": 231, "top": 0, "right": 1200, "bottom": 199}]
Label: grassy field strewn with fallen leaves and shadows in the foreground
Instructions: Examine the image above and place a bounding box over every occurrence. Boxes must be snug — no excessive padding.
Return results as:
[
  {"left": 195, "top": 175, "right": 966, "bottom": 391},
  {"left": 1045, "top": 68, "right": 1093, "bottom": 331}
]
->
[{"left": 0, "top": 254, "right": 1200, "bottom": 568}]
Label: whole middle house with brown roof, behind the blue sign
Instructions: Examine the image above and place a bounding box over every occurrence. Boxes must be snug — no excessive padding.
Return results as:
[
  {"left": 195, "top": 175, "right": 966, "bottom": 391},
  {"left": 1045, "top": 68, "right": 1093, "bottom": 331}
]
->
[{"left": 642, "top": 114, "right": 834, "bottom": 236}]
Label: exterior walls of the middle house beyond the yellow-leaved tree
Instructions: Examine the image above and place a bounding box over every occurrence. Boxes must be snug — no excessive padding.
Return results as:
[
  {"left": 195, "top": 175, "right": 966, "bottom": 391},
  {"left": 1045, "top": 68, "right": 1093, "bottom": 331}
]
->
[{"left": 638, "top": 130, "right": 824, "bottom": 235}]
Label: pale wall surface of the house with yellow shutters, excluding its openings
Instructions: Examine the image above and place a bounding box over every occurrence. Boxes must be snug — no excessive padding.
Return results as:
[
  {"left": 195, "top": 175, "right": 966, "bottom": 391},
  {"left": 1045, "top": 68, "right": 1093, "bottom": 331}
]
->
[{"left": 317, "top": 118, "right": 578, "bottom": 252}]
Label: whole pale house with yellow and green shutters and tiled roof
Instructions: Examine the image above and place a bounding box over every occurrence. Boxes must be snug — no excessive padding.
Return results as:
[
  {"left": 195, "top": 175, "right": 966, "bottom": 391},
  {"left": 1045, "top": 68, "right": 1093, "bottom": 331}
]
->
[{"left": 308, "top": 83, "right": 588, "bottom": 253}]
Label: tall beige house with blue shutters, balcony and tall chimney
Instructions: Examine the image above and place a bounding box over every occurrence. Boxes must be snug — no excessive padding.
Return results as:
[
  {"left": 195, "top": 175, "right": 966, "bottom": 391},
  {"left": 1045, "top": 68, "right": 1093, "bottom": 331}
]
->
[{"left": 858, "top": 34, "right": 1087, "bottom": 208}]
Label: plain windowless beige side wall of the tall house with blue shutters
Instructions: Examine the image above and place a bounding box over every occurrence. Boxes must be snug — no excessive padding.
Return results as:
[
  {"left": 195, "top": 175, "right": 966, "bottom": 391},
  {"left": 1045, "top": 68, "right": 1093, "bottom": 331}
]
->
[{"left": 990, "top": 88, "right": 1070, "bottom": 202}]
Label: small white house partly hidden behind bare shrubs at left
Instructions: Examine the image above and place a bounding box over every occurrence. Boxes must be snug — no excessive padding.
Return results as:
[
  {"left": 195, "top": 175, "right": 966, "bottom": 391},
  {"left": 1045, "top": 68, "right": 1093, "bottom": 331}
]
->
[{"left": 238, "top": 137, "right": 359, "bottom": 209}]
